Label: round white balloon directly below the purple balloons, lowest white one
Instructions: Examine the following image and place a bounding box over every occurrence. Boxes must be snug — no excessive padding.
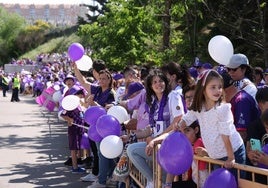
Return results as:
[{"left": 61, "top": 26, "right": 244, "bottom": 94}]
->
[{"left": 100, "top": 135, "right": 123, "bottom": 159}]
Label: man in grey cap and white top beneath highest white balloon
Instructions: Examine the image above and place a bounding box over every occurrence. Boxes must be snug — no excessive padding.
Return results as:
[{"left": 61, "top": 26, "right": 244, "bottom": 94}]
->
[{"left": 226, "top": 54, "right": 257, "bottom": 98}]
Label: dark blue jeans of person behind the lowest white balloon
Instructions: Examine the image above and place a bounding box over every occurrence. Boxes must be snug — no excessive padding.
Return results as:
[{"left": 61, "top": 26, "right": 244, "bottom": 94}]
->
[{"left": 96, "top": 142, "right": 116, "bottom": 184}]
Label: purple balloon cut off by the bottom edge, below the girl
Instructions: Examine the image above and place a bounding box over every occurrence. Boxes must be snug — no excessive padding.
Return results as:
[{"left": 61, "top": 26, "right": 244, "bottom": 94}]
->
[{"left": 204, "top": 168, "right": 237, "bottom": 188}]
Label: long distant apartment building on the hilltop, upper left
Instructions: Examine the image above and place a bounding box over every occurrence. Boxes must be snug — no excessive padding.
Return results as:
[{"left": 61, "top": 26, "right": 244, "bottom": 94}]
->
[{"left": 0, "top": 3, "right": 88, "bottom": 26}]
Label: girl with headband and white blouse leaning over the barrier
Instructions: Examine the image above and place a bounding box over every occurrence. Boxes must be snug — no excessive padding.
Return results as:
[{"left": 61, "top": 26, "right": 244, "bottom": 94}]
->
[{"left": 174, "top": 70, "right": 246, "bottom": 177}]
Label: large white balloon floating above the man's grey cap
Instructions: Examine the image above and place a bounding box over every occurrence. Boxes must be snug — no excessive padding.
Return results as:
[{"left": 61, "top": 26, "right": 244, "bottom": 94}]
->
[{"left": 208, "top": 35, "right": 234, "bottom": 65}]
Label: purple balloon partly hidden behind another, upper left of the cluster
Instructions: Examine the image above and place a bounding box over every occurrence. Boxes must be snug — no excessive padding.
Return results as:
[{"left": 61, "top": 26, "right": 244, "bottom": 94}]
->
[{"left": 84, "top": 106, "right": 107, "bottom": 126}]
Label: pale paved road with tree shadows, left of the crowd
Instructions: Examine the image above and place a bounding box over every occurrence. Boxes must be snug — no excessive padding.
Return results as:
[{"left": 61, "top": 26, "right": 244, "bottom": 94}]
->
[{"left": 0, "top": 92, "right": 90, "bottom": 188}]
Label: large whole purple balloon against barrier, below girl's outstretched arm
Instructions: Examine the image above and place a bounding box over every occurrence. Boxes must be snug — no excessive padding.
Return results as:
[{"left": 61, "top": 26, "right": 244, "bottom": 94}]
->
[{"left": 157, "top": 132, "right": 193, "bottom": 175}]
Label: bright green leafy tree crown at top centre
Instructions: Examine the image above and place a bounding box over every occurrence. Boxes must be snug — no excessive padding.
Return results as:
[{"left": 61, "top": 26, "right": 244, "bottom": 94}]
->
[{"left": 78, "top": 0, "right": 161, "bottom": 69}]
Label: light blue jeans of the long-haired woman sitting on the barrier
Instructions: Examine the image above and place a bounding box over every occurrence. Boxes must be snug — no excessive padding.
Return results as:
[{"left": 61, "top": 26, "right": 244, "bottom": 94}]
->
[{"left": 127, "top": 142, "right": 153, "bottom": 181}]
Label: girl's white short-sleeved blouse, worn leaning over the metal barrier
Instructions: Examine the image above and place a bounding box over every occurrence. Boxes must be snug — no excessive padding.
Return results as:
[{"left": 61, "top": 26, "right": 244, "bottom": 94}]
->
[{"left": 182, "top": 103, "right": 243, "bottom": 159}]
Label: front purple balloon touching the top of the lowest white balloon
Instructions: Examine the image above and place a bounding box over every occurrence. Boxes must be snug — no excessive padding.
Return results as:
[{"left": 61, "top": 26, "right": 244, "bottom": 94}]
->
[{"left": 96, "top": 115, "right": 121, "bottom": 138}]
